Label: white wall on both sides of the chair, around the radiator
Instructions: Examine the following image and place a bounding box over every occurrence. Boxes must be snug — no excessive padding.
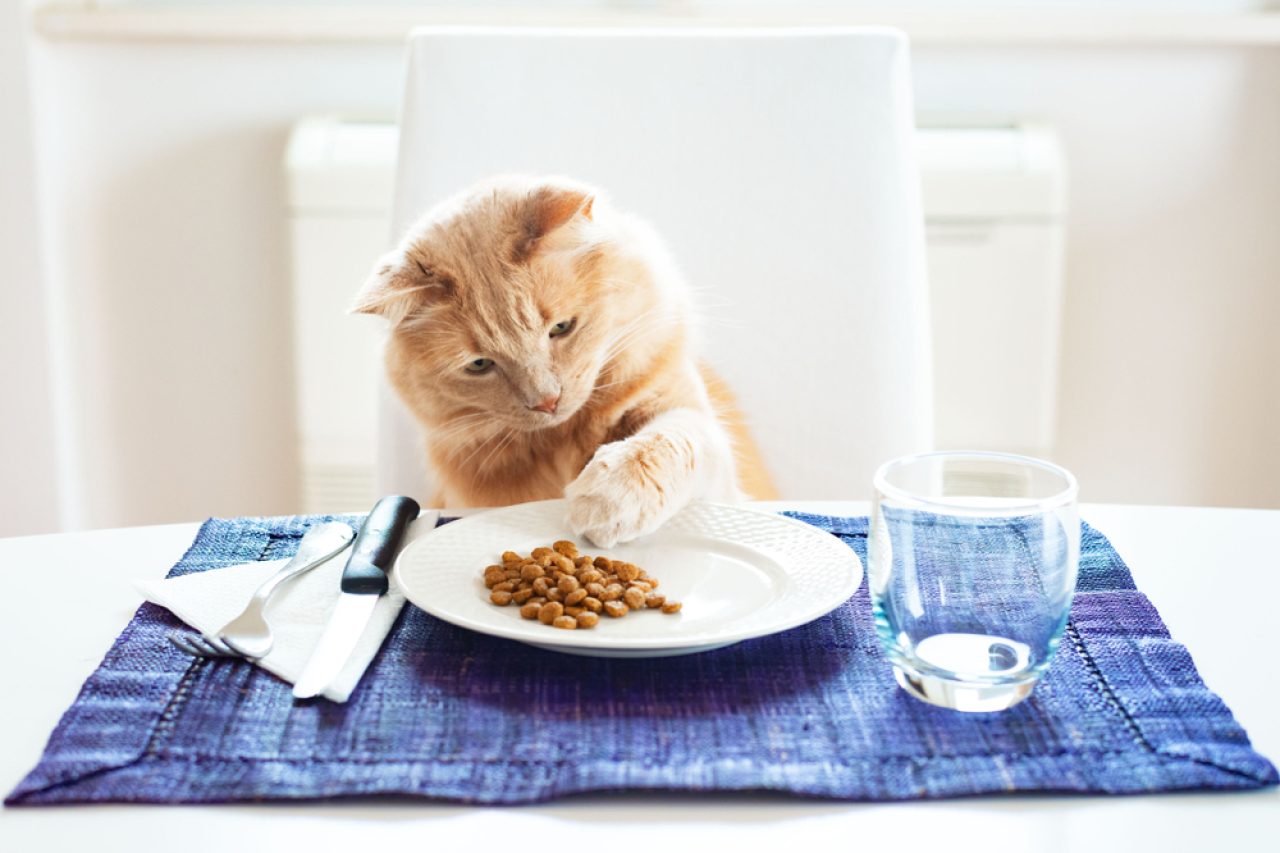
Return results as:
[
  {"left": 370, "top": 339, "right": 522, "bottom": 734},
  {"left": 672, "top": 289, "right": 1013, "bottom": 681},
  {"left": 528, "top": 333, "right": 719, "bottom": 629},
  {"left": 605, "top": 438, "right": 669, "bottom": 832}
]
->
[{"left": 20, "top": 28, "right": 1280, "bottom": 526}]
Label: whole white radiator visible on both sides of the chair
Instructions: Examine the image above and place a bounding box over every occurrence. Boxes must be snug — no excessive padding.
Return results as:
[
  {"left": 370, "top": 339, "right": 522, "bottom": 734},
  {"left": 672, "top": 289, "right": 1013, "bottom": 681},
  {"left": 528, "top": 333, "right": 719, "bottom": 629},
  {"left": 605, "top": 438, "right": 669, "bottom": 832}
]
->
[{"left": 285, "top": 118, "right": 1065, "bottom": 512}]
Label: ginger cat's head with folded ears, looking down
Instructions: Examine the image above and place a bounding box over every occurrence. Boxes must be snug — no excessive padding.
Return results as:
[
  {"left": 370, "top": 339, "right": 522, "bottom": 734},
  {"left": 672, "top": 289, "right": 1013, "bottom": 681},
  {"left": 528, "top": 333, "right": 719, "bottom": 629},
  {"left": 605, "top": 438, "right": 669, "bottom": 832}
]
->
[{"left": 352, "top": 178, "right": 634, "bottom": 430}]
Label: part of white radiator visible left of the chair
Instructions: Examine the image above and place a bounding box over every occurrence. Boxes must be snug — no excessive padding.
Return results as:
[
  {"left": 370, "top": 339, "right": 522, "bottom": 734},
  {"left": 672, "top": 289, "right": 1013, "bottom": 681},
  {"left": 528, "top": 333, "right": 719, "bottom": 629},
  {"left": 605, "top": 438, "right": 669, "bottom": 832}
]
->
[{"left": 285, "top": 118, "right": 396, "bottom": 512}]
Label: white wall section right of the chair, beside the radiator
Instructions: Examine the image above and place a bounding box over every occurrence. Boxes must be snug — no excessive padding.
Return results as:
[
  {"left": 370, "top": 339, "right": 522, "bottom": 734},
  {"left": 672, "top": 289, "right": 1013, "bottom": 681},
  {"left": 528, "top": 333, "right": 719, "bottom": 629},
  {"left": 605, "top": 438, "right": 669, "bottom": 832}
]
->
[{"left": 915, "top": 47, "right": 1280, "bottom": 507}]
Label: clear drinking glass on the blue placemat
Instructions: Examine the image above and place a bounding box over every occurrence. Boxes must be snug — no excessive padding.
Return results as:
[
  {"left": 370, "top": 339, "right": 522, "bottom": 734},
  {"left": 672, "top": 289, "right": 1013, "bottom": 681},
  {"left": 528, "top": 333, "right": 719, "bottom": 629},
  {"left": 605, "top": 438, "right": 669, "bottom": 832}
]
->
[{"left": 867, "top": 451, "right": 1080, "bottom": 711}]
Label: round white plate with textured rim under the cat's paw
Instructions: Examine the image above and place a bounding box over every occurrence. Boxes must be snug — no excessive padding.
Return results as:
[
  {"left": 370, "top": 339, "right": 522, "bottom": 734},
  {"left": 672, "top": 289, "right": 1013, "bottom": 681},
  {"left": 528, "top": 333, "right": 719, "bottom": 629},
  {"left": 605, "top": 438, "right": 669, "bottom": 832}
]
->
[{"left": 394, "top": 501, "right": 863, "bottom": 657}]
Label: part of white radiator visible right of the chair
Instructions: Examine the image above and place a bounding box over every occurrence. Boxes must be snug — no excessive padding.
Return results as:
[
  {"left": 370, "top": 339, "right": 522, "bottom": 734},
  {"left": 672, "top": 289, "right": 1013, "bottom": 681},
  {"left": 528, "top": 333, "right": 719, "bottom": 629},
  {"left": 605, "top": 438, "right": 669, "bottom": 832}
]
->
[{"left": 916, "top": 124, "right": 1066, "bottom": 456}]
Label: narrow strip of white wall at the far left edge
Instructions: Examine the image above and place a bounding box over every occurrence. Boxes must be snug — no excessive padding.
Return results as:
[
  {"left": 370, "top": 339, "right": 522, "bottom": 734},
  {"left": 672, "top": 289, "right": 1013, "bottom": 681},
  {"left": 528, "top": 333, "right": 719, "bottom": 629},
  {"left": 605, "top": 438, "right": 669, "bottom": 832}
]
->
[{"left": 0, "top": 0, "right": 58, "bottom": 537}]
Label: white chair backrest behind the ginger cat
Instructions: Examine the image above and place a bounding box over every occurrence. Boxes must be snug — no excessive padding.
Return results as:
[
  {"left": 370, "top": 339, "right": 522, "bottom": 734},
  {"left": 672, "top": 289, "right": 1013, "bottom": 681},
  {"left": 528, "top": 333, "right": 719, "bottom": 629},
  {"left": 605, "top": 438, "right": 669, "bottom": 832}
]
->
[{"left": 379, "top": 28, "right": 932, "bottom": 500}]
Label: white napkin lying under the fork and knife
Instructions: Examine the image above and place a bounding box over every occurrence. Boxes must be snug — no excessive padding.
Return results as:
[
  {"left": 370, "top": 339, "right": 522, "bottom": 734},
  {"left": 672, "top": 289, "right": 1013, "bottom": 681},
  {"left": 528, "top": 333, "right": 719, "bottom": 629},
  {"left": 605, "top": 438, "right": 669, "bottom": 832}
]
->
[{"left": 134, "top": 512, "right": 439, "bottom": 702}]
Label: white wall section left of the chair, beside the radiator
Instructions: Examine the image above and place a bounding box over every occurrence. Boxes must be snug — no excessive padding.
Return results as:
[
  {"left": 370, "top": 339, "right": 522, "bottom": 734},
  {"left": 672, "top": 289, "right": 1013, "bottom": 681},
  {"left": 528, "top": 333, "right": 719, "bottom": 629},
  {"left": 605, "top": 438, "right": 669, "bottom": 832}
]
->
[{"left": 24, "top": 42, "right": 401, "bottom": 528}]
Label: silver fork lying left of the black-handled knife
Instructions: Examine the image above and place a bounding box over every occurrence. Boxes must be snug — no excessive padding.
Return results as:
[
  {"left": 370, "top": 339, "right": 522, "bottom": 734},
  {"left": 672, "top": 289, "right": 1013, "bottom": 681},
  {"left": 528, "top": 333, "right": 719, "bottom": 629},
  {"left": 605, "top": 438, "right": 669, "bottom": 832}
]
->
[{"left": 169, "top": 521, "right": 356, "bottom": 660}]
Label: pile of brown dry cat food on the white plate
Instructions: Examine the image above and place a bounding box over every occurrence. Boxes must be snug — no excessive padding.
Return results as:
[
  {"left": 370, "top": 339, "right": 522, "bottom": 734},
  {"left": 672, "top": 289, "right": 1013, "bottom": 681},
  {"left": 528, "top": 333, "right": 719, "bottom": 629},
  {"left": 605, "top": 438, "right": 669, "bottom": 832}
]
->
[{"left": 484, "top": 539, "right": 680, "bottom": 630}]
